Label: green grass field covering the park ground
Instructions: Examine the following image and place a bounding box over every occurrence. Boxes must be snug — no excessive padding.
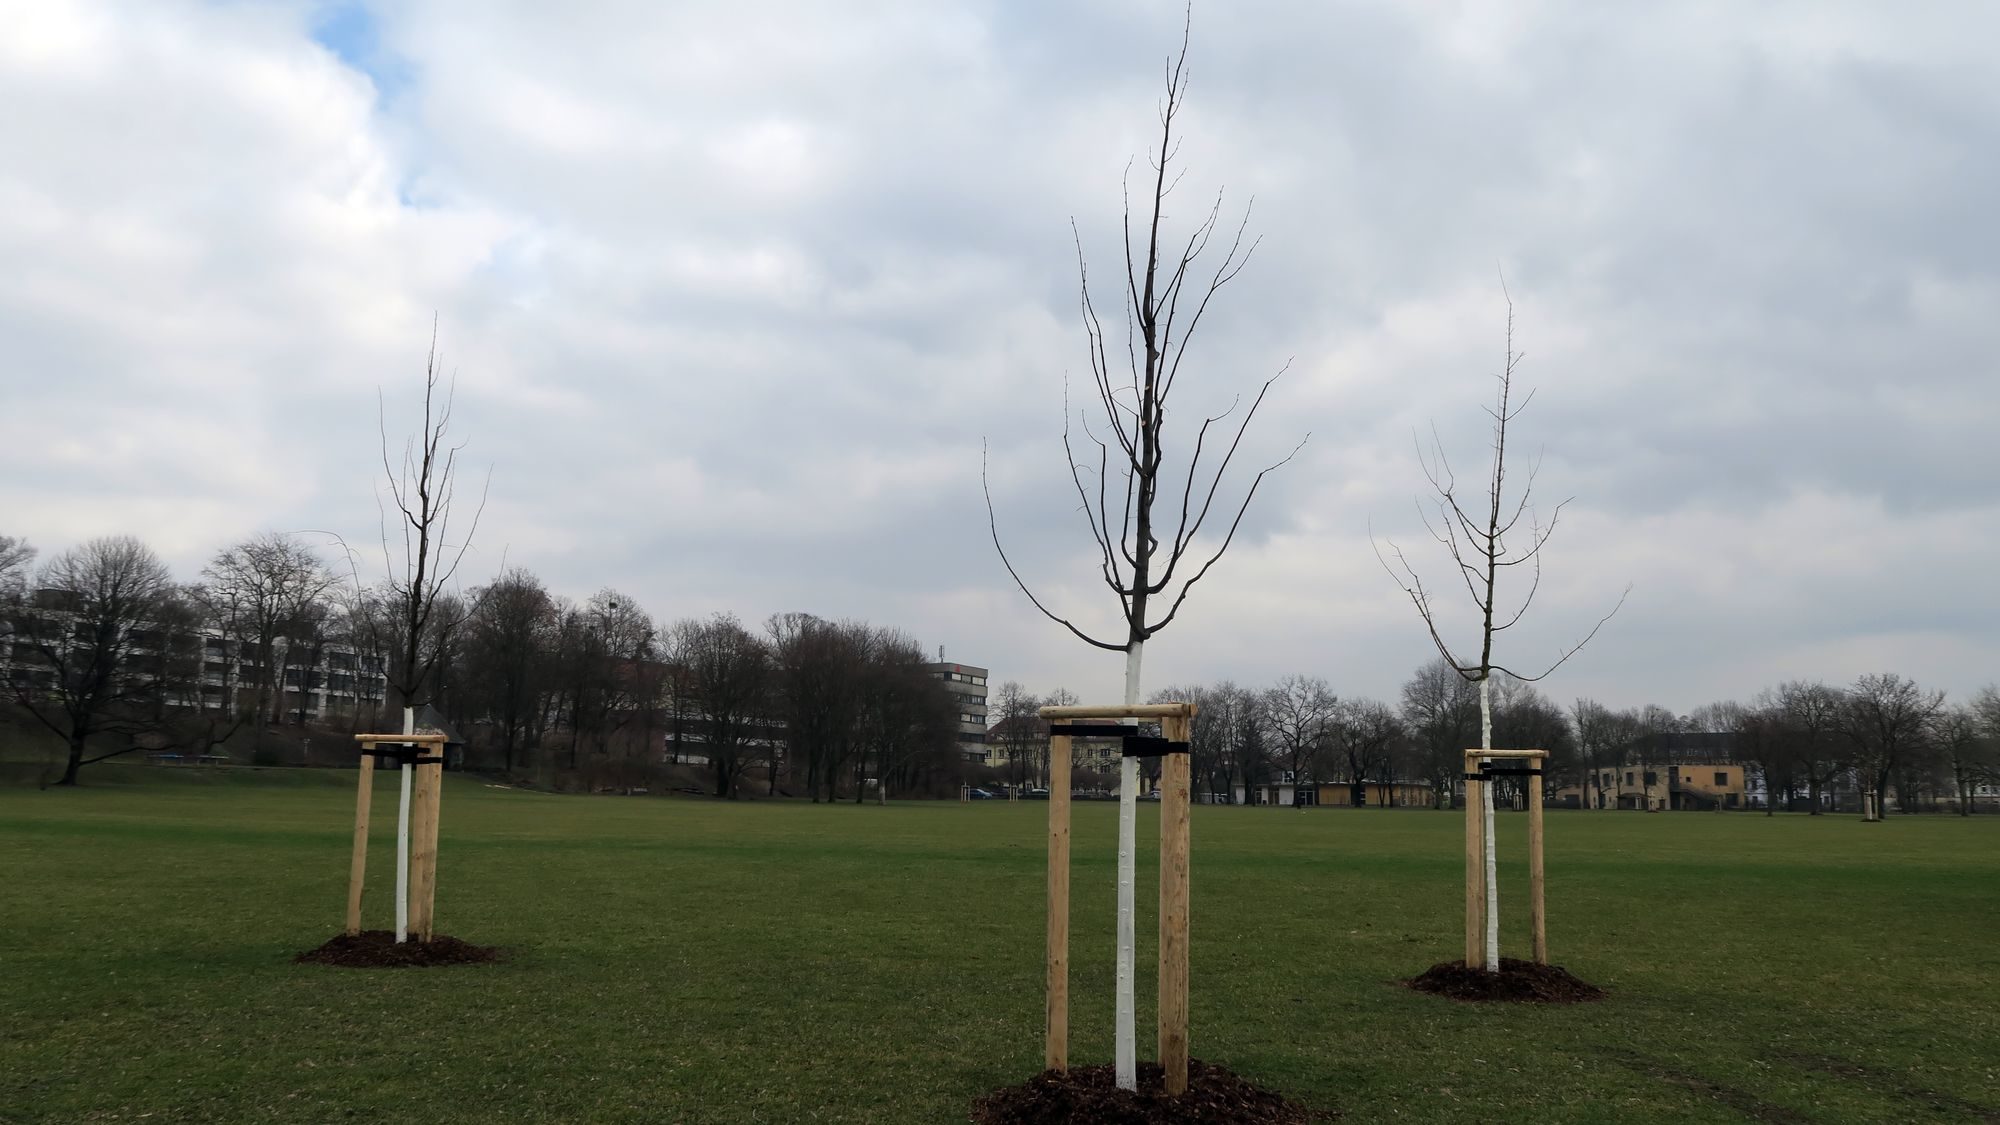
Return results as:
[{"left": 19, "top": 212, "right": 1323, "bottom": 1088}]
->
[{"left": 0, "top": 767, "right": 2000, "bottom": 1123}]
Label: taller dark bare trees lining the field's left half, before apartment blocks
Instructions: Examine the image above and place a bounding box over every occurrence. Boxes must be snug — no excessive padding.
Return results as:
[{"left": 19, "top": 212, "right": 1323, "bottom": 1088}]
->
[{"left": 0, "top": 532, "right": 964, "bottom": 801}]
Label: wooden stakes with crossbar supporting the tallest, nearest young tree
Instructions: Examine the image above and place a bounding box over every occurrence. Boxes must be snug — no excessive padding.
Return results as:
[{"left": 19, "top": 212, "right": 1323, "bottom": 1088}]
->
[{"left": 1040, "top": 703, "right": 1194, "bottom": 1095}]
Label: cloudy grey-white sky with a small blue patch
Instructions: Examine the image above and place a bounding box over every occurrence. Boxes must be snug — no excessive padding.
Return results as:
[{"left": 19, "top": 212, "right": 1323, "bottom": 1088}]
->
[{"left": 0, "top": 0, "right": 2000, "bottom": 711}]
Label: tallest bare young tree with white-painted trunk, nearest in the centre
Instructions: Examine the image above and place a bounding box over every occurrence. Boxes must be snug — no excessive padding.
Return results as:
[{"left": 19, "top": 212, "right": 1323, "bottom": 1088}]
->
[{"left": 986, "top": 28, "right": 1296, "bottom": 1089}]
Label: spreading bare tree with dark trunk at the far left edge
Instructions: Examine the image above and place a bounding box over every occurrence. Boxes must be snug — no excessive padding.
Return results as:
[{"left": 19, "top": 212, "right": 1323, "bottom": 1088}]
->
[{"left": 8, "top": 534, "right": 176, "bottom": 785}]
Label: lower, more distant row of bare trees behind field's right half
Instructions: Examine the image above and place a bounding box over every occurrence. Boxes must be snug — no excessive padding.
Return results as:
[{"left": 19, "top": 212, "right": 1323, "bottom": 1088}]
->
[{"left": 990, "top": 659, "right": 2000, "bottom": 815}]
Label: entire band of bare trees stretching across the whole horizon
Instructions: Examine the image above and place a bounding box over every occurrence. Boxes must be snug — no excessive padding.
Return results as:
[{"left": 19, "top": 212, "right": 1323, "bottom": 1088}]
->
[{"left": 15, "top": 532, "right": 2000, "bottom": 813}]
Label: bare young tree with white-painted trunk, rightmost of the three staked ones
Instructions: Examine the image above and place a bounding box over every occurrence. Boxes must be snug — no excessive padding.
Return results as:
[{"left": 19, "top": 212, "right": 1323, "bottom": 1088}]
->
[{"left": 1376, "top": 298, "right": 1630, "bottom": 973}]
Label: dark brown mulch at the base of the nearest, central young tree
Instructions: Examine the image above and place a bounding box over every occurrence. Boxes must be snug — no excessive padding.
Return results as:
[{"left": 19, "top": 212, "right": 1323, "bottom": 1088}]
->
[{"left": 972, "top": 1059, "right": 1340, "bottom": 1125}]
